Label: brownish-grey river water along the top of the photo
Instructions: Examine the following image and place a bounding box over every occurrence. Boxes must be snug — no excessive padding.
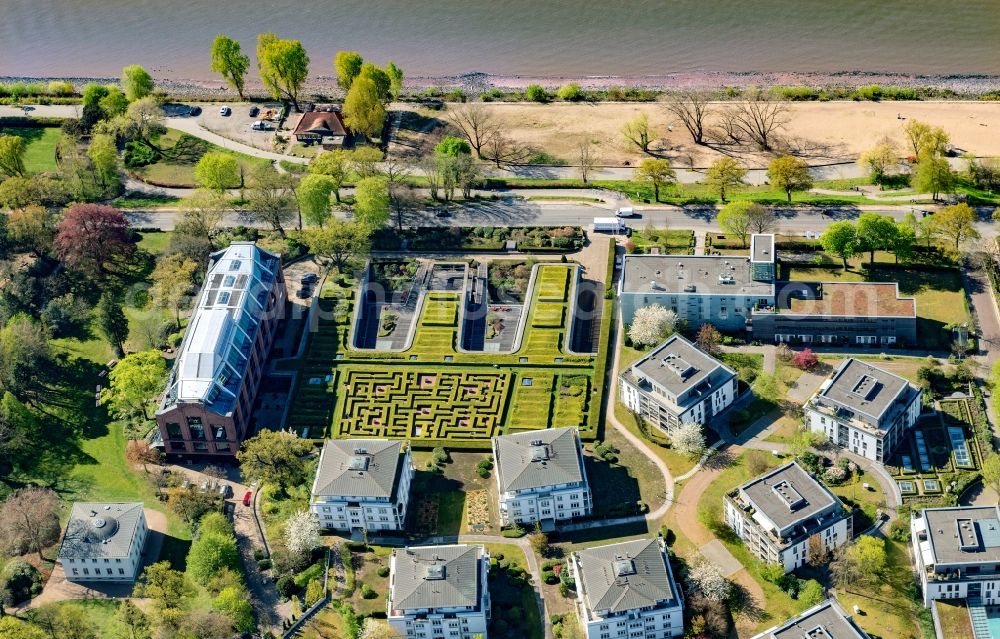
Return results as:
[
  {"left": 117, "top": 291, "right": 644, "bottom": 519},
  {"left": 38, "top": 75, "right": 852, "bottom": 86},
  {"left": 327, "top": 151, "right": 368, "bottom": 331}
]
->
[{"left": 0, "top": 0, "right": 1000, "bottom": 79}]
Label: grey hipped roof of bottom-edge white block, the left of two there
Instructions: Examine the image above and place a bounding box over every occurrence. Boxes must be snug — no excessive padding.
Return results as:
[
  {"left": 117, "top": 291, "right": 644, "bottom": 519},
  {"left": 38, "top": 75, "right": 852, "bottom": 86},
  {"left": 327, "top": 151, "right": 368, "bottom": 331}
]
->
[{"left": 389, "top": 544, "right": 484, "bottom": 610}]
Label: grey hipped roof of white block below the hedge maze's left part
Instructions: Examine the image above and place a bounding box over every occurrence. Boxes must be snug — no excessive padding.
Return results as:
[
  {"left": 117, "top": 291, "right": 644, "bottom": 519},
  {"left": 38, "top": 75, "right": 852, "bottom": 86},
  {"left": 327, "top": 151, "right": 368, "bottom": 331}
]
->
[{"left": 312, "top": 439, "right": 404, "bottom": 499}]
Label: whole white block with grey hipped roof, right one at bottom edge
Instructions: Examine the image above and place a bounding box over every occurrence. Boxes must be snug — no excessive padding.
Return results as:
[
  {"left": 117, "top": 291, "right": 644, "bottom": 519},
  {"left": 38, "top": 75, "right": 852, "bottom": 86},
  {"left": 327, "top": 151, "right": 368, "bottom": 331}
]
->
[{"left": 569, "top": 537, "right": 684, "bottom": 639}]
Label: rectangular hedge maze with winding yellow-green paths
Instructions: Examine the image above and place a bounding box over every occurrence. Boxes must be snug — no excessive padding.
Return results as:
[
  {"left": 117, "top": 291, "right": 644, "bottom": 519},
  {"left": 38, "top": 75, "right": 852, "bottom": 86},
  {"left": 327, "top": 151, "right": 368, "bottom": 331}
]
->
[{"left": 335, "top": 369, "right": 512, "bottom": 441}]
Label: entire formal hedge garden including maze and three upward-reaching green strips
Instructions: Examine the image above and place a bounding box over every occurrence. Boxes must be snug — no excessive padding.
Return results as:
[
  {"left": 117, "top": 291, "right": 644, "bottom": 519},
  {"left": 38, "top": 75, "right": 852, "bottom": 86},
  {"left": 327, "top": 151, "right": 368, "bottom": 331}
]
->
[{"left": 289, "top": 264, "right": 612, "bottom": 449}]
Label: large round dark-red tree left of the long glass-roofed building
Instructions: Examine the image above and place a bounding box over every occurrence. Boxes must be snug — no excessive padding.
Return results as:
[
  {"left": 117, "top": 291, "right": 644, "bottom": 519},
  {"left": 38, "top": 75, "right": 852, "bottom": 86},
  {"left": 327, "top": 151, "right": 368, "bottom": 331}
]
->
[{"left": 55, "top": 204, "right": 135, "bottom": 275}]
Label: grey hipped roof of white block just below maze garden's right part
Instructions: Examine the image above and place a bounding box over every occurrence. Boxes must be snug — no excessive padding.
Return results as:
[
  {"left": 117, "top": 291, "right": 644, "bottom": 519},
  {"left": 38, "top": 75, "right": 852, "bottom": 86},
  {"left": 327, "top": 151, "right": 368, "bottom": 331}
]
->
[{"left": 496, "top": 427, "right": 586, "bottom": 492}]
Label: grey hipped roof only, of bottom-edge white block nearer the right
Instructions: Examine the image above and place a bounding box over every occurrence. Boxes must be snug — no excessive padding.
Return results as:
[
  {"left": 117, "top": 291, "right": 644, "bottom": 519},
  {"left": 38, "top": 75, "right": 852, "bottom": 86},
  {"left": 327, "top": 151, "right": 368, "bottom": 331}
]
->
[{"left": 575, "top": 537, "right": 676, "bottom": 614}]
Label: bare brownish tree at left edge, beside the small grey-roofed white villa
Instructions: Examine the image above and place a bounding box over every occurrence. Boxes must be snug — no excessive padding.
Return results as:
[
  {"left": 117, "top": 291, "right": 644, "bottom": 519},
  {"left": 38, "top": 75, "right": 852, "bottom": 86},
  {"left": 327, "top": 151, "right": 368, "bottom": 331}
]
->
[{"left": 0, "top": 487, "right": 61, "bottom": 561}]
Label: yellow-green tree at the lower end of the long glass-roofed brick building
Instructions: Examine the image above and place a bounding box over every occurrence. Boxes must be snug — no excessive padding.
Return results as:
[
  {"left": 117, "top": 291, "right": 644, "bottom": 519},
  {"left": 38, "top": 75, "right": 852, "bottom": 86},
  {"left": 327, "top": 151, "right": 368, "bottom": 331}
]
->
[{"left": 236, "top": 430, "right": 312, "bottom": 491}]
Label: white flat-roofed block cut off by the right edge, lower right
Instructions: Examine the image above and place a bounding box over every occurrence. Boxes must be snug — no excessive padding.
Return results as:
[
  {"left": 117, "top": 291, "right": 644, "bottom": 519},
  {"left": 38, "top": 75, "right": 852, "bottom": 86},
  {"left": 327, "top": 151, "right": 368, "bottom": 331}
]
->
[{"left": 910, "top": 505, "right": 1000, "bottom": 609}]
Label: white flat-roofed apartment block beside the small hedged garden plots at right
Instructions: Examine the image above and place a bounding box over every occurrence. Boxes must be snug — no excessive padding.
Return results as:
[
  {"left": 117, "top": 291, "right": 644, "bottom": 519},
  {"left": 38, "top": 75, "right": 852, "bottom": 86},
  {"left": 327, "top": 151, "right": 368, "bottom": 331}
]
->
[{"left": 804, "top": 358, "right": 922, "bottom": 463}]
